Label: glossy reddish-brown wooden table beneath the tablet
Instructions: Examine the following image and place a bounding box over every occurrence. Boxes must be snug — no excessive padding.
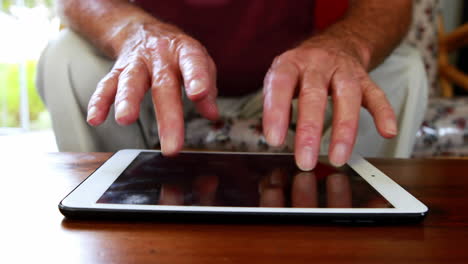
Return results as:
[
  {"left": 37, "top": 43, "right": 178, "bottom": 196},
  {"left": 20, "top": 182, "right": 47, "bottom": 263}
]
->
[{"left": 0, "top": 153, "right": 468, "bottom": 264}]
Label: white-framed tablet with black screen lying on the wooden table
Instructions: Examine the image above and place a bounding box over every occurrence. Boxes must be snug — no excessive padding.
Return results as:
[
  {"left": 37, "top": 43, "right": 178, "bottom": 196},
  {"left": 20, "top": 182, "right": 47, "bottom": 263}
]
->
[{"left": 59, "top": 150, "right": 428, "bottom": 223}]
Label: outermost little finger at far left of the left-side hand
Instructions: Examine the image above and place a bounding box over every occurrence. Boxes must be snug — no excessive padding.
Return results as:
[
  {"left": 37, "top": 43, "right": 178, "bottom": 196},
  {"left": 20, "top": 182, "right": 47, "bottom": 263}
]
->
[{"left": 86, "top": 69, "right": 121, "bottom": 126}]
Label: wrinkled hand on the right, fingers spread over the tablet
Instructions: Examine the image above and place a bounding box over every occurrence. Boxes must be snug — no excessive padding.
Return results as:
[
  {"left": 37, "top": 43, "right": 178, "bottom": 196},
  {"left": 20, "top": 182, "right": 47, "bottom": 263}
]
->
[{"left": 263, "top": 35, "right": 397, "bottom": 171}]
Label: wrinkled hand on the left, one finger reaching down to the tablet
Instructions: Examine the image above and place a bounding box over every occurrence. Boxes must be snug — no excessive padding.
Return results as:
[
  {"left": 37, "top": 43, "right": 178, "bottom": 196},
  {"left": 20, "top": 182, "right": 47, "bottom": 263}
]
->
[{"left": 87, "top": 22, "right": 218, "bottom": 156}]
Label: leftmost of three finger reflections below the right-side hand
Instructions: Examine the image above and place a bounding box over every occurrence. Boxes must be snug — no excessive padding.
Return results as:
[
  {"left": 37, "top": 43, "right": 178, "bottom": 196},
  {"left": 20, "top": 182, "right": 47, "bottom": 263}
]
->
[{"left": 259, "top": 169, "right": 287, "bottom": 207}]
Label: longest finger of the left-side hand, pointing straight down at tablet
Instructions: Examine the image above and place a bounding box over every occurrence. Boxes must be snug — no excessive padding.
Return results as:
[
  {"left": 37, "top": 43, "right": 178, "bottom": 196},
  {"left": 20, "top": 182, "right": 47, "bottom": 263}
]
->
[{"left": 151, "top": 60, "right": 184, "bottom": 156}]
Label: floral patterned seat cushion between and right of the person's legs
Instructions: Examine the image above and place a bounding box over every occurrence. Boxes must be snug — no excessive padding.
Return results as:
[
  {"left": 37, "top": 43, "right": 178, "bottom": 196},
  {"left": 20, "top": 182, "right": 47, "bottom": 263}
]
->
[{"left": 182, "top": 97, "right": 468, "bottom": 157}]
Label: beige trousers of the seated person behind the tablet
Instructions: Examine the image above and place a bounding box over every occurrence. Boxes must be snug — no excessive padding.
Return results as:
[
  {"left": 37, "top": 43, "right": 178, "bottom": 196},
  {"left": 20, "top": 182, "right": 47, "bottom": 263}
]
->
[{"left": 37, "top": 30, "right": 428, "bottom": 158}]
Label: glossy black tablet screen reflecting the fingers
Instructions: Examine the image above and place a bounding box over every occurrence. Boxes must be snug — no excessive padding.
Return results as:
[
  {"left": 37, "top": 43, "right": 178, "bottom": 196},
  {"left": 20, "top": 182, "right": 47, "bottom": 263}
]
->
[{"left": 97, "top": 152, "right": 393, "bottom": 208}]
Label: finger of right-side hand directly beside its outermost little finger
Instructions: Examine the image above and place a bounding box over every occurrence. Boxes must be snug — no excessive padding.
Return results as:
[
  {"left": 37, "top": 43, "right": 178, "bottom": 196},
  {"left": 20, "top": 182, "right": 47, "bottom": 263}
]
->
[{"left": 329, "top": 67, "right": 362, "bottom": 167}]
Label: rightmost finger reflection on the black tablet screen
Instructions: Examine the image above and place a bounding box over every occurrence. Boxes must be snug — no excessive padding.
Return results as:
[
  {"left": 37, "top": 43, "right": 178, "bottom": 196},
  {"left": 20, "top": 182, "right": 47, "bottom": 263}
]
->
[{"left": 326, "top": 173, "right": 352, "bottom": 208}]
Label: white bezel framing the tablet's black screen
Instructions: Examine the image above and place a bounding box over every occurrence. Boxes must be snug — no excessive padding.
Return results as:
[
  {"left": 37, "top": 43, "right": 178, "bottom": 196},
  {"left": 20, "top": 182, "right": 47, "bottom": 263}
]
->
[{"left": 61, "top": 149, "right": 428, "bottom": 215}]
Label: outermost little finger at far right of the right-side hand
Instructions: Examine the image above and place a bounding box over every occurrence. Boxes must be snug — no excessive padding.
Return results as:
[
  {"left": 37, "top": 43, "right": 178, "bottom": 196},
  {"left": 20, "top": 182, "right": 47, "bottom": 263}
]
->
[{"left": 361, "top": 72, "right": 398, "bottom": 138}]
